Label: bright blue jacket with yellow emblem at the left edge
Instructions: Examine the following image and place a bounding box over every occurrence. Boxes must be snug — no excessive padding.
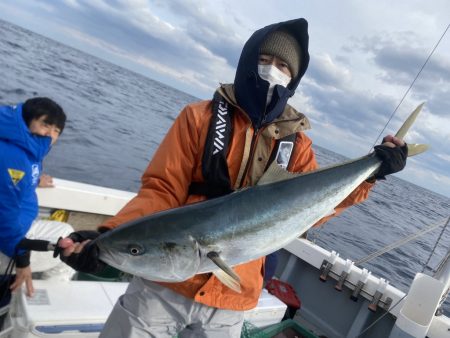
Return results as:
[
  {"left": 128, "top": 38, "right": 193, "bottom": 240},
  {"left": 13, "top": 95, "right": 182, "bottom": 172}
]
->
[{"left": 0, "top": 104, "right": 51, "bottom": 257}]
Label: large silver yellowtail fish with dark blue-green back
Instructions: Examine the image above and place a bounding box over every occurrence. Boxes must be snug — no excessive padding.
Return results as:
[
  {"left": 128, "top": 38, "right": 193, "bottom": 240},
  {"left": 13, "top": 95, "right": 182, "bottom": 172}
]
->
[{"left": 95, "top": 101, "right": 426, "bottom": 292}]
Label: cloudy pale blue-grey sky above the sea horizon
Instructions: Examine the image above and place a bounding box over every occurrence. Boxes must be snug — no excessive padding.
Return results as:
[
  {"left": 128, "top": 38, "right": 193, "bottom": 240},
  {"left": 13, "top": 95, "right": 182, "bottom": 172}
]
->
[{"left": 0, "top": 0, "right": 450, "bottom": 196}]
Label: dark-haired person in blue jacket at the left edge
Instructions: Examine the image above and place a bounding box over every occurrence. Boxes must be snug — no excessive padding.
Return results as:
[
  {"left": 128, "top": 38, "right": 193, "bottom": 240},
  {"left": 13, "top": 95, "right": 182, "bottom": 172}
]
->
[{"left": 0, "top": 97, "right": 71, "bottom": 296}]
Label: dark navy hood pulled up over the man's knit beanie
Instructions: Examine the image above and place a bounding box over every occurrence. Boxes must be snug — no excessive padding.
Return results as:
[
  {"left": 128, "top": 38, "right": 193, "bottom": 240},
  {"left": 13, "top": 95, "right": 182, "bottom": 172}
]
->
[{"left": 234, "top": 19, "right": 309, "bottom": 128}]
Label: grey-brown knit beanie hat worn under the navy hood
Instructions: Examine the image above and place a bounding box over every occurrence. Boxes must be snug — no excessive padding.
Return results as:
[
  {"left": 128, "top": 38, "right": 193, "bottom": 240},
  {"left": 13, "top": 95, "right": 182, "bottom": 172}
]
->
[{"left": 259, "top": 30, "right": 302, "bottom": 79}]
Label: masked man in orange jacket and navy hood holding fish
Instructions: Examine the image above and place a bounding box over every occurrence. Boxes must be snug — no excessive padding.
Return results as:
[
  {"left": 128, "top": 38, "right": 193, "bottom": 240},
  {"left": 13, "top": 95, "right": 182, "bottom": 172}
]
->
[{"left": 61, "top": 19, "right": 406, "bottom": 338}]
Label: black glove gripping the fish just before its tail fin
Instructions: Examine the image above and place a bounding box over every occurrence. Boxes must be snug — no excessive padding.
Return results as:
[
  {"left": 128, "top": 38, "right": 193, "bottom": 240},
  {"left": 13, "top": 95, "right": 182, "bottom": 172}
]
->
[{"left": 374, "top": 143, "right": 408, "bottom": 180}]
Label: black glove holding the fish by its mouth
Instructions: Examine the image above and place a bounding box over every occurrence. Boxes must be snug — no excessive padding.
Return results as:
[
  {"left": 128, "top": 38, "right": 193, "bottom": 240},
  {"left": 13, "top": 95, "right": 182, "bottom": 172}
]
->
[{"left": 55, "top": 230, "right": 106, "bottom": 273}]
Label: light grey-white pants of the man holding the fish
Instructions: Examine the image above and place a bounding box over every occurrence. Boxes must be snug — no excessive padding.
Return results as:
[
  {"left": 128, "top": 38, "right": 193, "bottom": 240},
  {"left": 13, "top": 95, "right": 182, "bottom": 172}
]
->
[{"left": 100, "top": 277, "right": 244, "bottom": 338}]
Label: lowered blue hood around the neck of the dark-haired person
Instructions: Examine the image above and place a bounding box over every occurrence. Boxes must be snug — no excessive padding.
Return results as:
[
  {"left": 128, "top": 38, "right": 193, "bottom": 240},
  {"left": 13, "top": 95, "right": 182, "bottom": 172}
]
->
[{"left": 0, "top": 104, "right": 52, "bottom": 161}]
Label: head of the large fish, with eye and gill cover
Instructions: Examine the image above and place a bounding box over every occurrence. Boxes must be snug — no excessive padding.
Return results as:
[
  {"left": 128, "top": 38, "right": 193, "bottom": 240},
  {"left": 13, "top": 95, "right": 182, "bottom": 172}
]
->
[{"left": 96, "top": 227, "right": 200, "bottom": 282}]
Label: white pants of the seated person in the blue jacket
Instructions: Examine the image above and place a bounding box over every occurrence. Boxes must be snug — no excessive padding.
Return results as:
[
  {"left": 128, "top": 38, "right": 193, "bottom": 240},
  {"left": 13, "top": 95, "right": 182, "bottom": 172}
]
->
[{"left": 0, "top": 220, "right": 75, "bottom": 281}]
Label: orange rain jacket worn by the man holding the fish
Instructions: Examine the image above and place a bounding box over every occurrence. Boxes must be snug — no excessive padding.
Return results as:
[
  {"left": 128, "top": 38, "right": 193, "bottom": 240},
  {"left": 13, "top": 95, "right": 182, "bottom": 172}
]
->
[{"left": 100, "top": 85, "right": 373, "bottom": 310}]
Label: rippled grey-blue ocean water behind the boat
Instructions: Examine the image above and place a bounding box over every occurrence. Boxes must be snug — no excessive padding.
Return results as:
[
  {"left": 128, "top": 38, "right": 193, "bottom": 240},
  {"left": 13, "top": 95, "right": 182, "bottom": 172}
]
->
[{"left": 0, "top": 20, "right": 450, "bottom": 309}]
